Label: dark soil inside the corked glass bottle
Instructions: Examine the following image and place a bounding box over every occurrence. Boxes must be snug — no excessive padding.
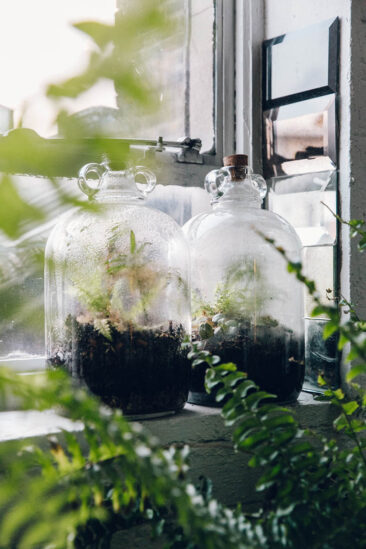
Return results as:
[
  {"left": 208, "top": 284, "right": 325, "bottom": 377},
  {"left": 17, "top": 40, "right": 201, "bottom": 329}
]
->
[{"left": 188, "top": 326, "right": 305, "bottom": 406}]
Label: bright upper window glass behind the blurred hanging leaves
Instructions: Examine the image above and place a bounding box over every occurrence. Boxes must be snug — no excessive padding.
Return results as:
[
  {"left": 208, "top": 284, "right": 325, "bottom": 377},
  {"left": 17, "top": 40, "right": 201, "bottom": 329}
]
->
[{"left": 0, "top": 0, "right": 215, "bottom": 150}]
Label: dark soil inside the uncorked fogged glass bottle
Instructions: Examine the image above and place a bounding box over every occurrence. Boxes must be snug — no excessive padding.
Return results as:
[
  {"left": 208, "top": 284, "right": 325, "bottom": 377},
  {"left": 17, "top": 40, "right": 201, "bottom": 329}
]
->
[{"left": 48, "top": 317, "right": 191, "bottom": 415}]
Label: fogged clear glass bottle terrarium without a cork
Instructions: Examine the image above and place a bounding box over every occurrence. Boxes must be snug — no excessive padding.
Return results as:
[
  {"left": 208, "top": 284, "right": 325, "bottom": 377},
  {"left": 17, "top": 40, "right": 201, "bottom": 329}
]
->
[{"left": 45, "top": 164, "right": 191, "bottom": 417}]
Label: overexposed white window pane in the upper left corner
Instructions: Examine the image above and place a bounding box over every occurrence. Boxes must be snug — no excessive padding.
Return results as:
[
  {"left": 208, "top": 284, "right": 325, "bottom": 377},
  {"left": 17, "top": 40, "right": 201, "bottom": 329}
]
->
[{"left": 0, "top": 0, "right": 116, "bottom": 137}]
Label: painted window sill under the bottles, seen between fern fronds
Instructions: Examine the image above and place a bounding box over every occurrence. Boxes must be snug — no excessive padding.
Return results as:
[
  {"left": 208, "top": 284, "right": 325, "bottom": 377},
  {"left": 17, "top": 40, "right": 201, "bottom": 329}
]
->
[{"left": 0, "top": 392, "right": 336, "bottom": 505}]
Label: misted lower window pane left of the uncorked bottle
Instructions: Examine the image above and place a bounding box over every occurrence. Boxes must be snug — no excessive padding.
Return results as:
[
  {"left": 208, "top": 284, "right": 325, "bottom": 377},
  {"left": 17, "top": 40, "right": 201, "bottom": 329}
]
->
[{"left": 0, "top": 176, "right": 82, "bottom": 371}]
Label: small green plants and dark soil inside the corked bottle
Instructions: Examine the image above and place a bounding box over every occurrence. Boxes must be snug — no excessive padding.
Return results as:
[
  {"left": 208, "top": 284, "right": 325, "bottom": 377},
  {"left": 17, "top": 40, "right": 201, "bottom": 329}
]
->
[{"left": 189, "top": 258, "right": 304, "bottom": 404}]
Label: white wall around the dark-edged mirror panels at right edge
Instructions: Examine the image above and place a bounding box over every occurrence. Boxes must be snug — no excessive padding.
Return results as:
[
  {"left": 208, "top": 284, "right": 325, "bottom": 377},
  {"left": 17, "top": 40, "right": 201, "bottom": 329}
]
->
[{"left": 264, "top": 0, "right": 366, "bottom": 386}]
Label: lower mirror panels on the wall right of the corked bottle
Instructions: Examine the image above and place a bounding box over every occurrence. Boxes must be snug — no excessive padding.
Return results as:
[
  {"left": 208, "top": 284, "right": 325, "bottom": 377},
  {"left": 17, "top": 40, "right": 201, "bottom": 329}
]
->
[{"left": 268, "top": 171, "right": 338, "bottom": 388}]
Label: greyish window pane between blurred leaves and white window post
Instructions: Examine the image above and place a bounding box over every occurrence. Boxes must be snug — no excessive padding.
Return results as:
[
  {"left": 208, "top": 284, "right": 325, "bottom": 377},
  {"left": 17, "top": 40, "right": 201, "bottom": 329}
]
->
[{"left": 117, "top": 0, "right": 215, "bottom": 151}]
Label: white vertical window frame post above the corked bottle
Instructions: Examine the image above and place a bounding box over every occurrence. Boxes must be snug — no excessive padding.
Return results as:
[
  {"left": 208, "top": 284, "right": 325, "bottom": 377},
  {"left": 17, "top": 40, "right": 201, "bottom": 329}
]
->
[{"left": 143, "top": 0, "right": 264, "bottom": 186}]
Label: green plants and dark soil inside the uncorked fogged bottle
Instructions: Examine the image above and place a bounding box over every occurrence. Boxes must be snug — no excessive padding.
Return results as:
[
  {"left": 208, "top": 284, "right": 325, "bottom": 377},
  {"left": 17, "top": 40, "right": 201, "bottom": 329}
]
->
[{"left": 48, "top": 230, "right": 191, "bottom": 415}]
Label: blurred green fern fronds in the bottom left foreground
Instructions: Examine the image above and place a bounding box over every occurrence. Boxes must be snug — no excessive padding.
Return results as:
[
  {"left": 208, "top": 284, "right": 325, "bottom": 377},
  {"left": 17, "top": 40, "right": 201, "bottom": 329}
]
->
[{"left": 0, "top": 370, "right": 259, "bottom": 549}]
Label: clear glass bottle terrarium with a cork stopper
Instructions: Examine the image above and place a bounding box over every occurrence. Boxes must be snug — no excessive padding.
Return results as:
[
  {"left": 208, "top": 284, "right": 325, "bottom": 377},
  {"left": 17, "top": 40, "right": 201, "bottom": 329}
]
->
[{"left": 183, "top": 155, "right": 304, "bottom": 405}]
